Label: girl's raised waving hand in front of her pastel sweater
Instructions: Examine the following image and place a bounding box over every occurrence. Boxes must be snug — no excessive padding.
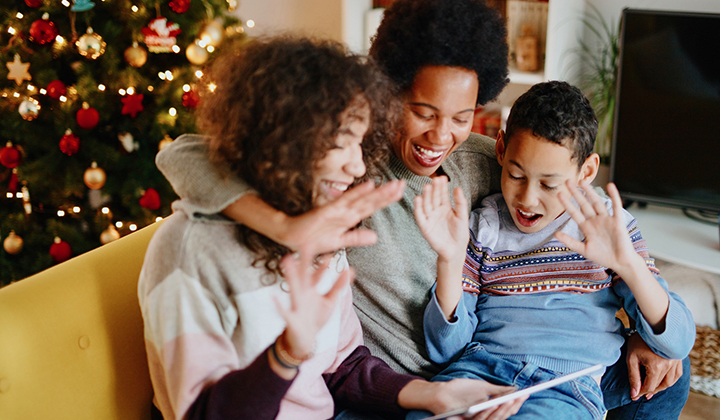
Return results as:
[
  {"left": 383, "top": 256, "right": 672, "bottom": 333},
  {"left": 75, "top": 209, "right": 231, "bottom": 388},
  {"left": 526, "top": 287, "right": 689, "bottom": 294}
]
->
[{"left": 275, "top": 251, "right": 353, "bottom": 360}]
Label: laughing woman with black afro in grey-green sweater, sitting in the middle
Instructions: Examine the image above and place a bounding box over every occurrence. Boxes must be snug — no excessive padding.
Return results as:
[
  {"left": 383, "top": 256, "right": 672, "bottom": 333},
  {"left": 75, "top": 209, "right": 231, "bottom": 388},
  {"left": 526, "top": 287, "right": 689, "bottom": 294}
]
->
[{"left": 158, "top": 0, "right": 689, "bottom": 418}]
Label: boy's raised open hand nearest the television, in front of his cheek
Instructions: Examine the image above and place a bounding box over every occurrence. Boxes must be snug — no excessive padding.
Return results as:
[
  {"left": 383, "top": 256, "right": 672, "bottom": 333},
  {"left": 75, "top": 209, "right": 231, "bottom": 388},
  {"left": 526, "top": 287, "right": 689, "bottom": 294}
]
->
[{"left": 555, "top": 181, "right": 644, "bottom": 276}]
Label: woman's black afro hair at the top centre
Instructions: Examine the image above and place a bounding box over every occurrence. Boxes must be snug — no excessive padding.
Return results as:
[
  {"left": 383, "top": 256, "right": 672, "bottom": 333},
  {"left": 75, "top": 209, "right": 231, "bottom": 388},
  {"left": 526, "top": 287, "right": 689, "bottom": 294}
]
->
[{"left": 370, "top": 0, "right": 509, "bottom": 105}]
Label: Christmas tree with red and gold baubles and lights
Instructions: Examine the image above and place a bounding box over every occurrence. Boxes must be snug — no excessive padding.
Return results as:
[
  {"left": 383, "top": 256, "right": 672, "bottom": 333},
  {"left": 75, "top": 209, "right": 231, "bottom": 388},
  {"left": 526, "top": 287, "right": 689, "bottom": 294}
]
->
[{"left": 0, "top": 0, "right": 243, "bottom": 286}]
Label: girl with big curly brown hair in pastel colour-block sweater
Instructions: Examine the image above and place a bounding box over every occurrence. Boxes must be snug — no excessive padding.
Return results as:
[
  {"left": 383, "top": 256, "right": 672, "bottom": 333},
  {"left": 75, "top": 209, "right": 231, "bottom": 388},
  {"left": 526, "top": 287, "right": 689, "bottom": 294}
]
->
[{"left": 138, "top": 38, "right": 519, "bottom": 420}]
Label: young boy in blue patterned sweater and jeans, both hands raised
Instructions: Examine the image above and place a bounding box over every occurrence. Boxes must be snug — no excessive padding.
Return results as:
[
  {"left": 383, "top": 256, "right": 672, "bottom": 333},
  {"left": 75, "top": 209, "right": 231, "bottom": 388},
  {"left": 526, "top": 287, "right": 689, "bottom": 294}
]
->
[{"left": 408, "top": 82, "right": 695, "bottom": 420}]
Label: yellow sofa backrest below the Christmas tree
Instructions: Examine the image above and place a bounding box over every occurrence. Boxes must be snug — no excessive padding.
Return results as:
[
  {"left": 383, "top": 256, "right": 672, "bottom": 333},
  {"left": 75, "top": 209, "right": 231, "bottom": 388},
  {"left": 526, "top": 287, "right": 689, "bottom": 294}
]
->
[{"left": 0, "top": 222, "right": 161, "bottom": 420}]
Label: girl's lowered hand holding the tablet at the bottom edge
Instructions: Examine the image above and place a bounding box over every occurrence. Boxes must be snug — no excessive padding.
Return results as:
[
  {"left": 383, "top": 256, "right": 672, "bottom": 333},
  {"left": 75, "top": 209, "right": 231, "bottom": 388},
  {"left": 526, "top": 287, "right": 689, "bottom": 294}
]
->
[{"left": 398, "top": 378, "right": 527, "bottom": 420}]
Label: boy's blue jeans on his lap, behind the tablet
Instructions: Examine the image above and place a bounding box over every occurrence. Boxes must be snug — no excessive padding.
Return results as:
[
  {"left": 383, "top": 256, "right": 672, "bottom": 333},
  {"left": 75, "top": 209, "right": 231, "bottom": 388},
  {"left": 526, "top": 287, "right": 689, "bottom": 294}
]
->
[{"left": 406, "top": 343, "right": 605, "bottom": 420}]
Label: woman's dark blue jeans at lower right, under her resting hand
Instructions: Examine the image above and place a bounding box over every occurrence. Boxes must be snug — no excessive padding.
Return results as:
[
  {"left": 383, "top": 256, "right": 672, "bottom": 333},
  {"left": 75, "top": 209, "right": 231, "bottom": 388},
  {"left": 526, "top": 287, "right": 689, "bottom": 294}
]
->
[{"left": 600, "top": 338, "right": 690, "bottom": 420}]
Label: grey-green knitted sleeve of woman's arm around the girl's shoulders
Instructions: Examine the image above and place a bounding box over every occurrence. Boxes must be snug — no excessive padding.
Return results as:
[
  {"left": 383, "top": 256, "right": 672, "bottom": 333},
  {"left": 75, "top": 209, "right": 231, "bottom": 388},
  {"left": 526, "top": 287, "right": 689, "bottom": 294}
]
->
[{"left": 155, "top": 134, "right": 254, "bottom": 216}]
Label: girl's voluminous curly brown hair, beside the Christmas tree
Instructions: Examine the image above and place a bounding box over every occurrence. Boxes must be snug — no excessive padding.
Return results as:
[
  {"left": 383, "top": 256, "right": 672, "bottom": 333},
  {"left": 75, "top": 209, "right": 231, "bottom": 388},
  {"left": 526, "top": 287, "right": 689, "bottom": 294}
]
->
[{"left": 197, "top": 36, "right": 401, "bottom": 274}]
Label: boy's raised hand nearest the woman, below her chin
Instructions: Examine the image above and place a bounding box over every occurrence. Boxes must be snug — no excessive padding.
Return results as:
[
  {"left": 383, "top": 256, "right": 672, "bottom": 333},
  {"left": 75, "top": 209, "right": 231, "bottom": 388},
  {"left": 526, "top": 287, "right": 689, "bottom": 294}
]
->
[{"left": 415, "top": 175, "right": 470, "bottom": 264}]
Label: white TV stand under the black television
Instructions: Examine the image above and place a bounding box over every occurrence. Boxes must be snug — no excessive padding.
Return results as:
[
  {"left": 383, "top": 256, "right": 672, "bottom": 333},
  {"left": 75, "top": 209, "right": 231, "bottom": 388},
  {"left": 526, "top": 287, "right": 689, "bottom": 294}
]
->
[{"left": 627, "top": 203, "right": 720, "bottom": 274}]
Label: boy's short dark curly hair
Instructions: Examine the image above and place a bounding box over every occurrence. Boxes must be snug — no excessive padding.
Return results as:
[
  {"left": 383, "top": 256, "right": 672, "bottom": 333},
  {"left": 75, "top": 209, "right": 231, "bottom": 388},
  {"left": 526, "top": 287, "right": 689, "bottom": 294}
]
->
[{"left": 505, "top": 80, "right": 598, "bottom": 167}]
